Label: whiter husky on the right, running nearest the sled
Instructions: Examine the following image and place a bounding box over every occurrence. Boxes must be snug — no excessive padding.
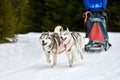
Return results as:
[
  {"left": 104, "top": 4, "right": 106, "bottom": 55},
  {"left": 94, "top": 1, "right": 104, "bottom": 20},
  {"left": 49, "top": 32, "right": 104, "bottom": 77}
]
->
[{"left": 60, "top": 28, "right": 85, "bottom": 67}]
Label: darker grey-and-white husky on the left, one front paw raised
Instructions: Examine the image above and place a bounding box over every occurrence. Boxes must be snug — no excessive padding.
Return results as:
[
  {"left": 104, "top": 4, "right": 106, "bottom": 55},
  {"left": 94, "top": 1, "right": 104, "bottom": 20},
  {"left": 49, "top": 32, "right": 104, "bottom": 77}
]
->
[{"left": 40, "top": 32, "right": 60, "bottom": 67}]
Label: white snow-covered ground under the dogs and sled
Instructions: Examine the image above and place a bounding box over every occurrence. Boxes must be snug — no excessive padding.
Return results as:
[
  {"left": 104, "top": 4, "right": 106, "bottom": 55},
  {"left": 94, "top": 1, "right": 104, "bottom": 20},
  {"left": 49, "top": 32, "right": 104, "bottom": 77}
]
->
[{"left": 0, "top": 32, "right": 120, "bottom": 80}]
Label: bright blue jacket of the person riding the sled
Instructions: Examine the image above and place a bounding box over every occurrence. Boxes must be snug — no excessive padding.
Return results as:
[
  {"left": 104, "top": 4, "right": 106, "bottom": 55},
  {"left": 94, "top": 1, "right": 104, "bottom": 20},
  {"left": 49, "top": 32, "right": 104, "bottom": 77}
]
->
[{"left": 84, "top": 0, "right": 107, "bottom": 12}]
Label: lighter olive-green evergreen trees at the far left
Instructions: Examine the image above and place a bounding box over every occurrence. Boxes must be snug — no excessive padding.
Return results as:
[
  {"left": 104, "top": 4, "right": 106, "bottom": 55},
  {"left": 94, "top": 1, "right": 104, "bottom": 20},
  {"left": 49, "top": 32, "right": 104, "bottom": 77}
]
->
[{"left": 0, "top": 0, "right": 28, "bottom": 43}]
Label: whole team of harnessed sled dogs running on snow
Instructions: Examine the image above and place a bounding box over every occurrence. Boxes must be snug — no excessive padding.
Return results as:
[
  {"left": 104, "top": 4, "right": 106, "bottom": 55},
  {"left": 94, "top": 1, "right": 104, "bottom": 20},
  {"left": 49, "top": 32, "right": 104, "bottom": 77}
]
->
[{"left": 40, "top": 26, "right": 85, "bottom": 67}]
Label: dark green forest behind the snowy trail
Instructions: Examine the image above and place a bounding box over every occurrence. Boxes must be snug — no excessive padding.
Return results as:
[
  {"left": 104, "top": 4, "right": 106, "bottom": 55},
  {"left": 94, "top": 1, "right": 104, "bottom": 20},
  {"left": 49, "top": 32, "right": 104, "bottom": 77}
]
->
[{"left": 0, "top": 0, "right": 120, "bottom": 43}]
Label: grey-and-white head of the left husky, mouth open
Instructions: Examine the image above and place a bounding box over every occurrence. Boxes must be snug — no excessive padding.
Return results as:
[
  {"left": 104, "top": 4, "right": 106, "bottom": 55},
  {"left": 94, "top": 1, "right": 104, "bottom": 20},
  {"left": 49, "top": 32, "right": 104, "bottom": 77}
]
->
[{"left": 40, "top": 32, "right": 52, "bottom": 46}]
